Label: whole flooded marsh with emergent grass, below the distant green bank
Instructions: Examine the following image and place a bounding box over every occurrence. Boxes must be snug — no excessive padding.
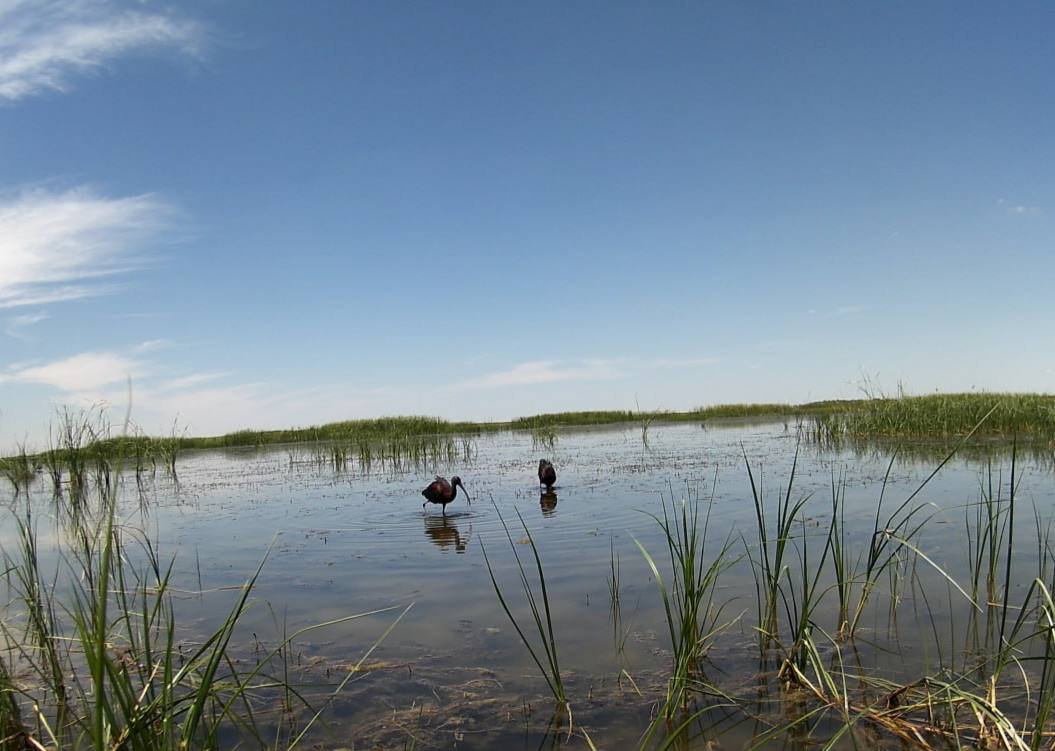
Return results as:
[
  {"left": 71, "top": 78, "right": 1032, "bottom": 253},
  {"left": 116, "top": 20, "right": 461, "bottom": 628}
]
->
[{"left": 6, "top": 407, "right": 1055, "bottom": 749}]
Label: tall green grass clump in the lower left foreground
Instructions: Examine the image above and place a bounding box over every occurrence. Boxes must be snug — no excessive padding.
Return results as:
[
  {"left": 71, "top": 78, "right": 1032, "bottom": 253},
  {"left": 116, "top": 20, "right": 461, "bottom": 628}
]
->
[{"left": 0, "top": 464, "right": 406, "bottom": 751}]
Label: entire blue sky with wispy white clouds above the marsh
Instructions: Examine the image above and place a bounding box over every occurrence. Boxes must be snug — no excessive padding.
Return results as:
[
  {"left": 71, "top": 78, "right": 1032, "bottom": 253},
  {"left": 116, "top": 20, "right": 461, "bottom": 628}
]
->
[{"left": 0, "top": 0, "right": 1055, "bottom": 446}]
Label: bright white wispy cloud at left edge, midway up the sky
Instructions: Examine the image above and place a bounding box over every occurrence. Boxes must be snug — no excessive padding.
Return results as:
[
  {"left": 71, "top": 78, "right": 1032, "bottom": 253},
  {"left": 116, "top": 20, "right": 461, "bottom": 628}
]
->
[{"left": 0, "top": 188, "right": 172, "bottom": 308}]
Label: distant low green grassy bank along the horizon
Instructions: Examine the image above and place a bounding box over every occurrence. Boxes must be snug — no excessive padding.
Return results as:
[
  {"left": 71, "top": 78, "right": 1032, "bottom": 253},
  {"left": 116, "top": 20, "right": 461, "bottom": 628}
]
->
[{"left": 10, "top": 392, "right": 1055, "bottom": 466}]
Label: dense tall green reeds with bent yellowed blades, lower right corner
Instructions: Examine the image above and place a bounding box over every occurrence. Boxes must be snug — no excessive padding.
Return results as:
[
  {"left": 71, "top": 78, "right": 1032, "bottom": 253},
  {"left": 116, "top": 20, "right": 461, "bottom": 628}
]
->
[{"left": 725, "top": 451, "right": 1055, "bottom": 749}]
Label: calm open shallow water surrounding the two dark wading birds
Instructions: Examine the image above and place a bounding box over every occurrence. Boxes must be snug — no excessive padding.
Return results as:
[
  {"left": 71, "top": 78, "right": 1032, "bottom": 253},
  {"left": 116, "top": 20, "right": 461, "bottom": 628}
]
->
[{"left": 0, "top": 423, "right": 1055, "bottom": 749}]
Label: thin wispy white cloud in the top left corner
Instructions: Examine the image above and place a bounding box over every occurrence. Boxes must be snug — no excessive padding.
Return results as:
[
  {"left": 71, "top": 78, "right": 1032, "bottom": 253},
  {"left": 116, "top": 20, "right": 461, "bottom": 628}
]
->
[{"left": 0, "top": 0, "right": 203, "bottom": 101}]
